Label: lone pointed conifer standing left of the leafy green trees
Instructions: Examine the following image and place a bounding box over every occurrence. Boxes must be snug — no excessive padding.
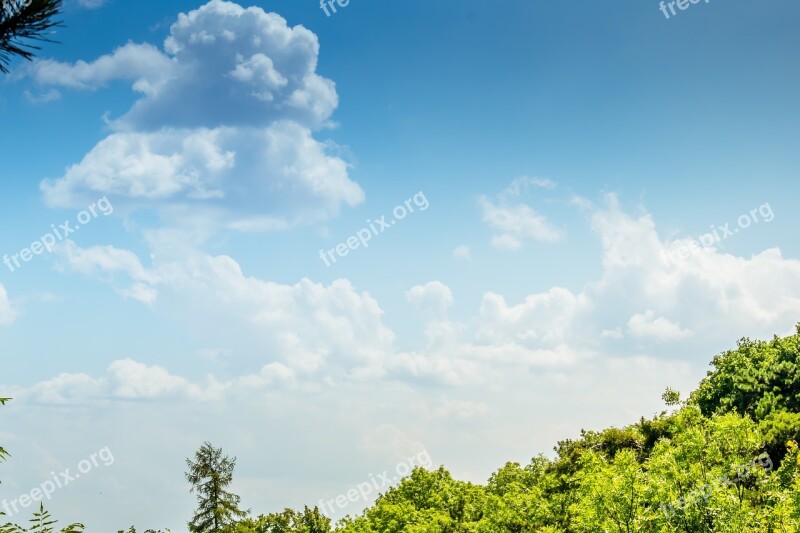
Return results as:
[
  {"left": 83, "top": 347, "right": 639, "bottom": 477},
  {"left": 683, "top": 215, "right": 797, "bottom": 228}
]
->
[{"left": 186, "top": 442, "right": 249, "bottom": 533}]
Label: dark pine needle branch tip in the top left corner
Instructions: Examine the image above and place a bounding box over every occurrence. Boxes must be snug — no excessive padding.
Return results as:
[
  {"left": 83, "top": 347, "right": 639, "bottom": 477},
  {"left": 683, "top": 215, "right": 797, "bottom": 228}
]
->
[{"left": 0, "top": 0, "right": 61, "bottom": 73}]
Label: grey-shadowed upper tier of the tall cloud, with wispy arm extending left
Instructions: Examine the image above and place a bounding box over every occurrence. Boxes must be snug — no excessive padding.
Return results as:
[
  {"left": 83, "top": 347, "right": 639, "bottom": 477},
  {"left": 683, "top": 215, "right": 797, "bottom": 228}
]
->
[{"left": 27, "top": 0, "right": 338, "bottom": 130}]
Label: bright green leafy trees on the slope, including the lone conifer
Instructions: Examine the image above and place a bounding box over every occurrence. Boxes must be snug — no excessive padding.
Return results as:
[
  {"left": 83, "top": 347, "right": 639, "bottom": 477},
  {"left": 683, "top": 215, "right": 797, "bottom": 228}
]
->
[{"left": 7, "top": 325, "right": 800, "bottom": 533}]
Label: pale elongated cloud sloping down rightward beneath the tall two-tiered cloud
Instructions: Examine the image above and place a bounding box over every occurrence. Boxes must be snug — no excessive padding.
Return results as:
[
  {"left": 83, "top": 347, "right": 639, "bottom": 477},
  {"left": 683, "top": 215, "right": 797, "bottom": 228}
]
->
[{"left": 54, "top": 234, "right": 395, "bottom": 377}]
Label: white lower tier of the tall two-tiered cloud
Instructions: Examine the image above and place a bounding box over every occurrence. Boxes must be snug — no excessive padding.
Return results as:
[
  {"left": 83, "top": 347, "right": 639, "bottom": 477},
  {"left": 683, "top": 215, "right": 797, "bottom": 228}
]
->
[{"left": 41, "top": 122, "right": 364, "bottom": 222}]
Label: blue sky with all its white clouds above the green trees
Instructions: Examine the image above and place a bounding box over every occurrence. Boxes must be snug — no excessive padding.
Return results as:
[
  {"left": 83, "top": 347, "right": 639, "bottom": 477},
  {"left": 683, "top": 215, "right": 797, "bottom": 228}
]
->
[{"left": 0, "top": 0, "right": 800, "bottom": 531}]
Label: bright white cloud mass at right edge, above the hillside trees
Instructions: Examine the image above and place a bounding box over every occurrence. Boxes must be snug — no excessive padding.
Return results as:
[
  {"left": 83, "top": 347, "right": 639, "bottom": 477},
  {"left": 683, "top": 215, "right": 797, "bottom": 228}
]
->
[{"left": 590, "top": 195, "right": 800, "bottom": 339}]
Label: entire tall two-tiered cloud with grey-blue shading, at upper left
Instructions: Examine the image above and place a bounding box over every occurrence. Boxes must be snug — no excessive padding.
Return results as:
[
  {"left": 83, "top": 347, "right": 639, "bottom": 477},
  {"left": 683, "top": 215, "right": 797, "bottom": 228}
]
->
[{"left": 27, "top": 0, "right": 364, "bottom": 231}]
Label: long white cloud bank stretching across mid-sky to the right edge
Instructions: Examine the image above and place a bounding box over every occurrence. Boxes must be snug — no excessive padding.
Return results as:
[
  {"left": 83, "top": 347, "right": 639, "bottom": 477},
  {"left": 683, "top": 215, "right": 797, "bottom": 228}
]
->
[{"left": 45, "top": 192, "right": 800, "bottom": 386}]
